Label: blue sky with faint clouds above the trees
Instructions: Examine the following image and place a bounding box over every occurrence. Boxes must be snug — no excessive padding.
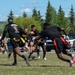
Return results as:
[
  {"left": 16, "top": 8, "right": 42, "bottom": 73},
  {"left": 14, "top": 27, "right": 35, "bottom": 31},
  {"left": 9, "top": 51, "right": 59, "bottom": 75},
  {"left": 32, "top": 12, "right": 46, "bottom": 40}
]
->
[{"left": 0, "top": 0, "right": 75, "bottom": 21}]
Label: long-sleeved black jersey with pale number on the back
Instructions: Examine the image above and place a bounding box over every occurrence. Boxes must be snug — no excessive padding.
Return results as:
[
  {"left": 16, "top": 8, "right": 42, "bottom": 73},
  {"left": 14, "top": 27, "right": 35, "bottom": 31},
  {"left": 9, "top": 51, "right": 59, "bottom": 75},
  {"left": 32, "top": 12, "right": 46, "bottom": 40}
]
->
[{"left": 2, "top": 24, "right": 25, "bottom": 39}]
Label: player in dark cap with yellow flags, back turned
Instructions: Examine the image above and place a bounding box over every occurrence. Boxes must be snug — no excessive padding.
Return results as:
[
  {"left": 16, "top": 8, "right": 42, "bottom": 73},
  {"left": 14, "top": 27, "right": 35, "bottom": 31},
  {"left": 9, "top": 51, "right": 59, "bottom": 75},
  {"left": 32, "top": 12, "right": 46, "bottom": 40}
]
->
[{"left": 1, "top": 17, "right": 30, "bottom": 66}]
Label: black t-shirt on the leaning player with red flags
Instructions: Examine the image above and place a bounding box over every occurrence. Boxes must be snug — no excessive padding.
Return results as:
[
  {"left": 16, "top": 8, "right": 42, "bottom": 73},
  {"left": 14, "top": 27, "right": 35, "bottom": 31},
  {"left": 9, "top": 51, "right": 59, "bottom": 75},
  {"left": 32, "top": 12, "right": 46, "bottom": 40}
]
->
[{"left": 41, "top": 26, "right": 61, "bottom": 39}]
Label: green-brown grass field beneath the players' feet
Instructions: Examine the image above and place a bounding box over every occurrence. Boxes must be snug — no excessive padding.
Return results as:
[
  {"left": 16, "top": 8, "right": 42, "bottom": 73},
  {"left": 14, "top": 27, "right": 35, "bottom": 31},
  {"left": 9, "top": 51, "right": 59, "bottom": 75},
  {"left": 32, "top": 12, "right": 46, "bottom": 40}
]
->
[{"left": 0, "top": 53, "right": 75, "bottom": 75}]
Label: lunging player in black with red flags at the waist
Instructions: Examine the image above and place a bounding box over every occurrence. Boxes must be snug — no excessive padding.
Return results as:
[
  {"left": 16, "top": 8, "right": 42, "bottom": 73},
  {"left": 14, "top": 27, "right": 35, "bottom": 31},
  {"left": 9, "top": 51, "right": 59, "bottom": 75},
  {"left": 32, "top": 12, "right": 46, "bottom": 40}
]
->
[{"left": 41, "top": 23, "right": 74, "bottom": 66}]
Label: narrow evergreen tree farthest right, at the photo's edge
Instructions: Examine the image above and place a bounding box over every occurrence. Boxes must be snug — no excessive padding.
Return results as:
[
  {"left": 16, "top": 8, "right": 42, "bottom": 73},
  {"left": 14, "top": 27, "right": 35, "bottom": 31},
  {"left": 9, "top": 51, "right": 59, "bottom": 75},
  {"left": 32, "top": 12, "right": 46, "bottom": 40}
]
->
[{"left": 69, "top": 5, "right": 75, "bottom": 33}]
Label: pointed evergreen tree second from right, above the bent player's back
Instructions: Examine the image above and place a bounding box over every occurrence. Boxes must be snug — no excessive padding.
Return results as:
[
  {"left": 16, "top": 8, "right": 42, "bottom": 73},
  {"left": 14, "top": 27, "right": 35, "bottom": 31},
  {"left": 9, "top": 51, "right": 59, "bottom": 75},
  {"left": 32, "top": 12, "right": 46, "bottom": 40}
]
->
[{"left": 57, "top": 6, "right": 69, "bottom": 31}]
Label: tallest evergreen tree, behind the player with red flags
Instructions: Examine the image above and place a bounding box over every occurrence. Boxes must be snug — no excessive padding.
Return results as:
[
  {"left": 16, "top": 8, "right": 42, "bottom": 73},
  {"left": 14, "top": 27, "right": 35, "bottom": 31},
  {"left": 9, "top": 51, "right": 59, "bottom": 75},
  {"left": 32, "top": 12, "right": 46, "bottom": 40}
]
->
[{"left": 46, "top": 1, "right": 56, "bottom": 25}]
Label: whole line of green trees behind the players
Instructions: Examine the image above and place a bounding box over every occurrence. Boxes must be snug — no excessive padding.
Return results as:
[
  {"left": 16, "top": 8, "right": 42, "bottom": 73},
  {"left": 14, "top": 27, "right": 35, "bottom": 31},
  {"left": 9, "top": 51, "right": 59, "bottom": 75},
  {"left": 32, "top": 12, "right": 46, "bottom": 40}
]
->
[{"left": 3, "top": 1, "right": 75, "bottom": 34}]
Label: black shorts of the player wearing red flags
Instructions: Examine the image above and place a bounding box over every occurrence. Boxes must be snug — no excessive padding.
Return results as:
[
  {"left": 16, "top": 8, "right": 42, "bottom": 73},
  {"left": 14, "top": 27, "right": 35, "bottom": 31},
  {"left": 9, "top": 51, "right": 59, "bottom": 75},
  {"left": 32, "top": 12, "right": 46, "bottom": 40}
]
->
[{"left": 55, "top": 38, "right": 66, "bottom": 54}]
